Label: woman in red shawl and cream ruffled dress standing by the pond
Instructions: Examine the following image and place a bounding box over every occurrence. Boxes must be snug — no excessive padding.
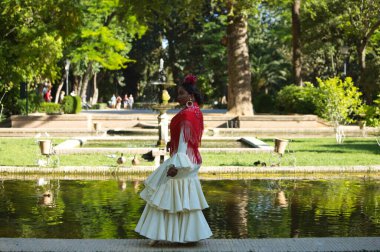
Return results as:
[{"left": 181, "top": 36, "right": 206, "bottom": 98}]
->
[{"left": 135, "top": 75, "right": 212, "bottom": 246}]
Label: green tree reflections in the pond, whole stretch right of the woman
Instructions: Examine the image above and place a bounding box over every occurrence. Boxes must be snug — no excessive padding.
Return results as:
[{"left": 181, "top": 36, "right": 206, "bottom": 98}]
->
[{"left": 202, "top": 180, "right": 380, "bottom": 238}]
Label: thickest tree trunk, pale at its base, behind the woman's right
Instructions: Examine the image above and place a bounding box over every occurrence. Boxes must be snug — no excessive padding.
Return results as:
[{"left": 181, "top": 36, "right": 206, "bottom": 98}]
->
[{"left": 227, "top": 13, "right": 253, "bottom": 116}]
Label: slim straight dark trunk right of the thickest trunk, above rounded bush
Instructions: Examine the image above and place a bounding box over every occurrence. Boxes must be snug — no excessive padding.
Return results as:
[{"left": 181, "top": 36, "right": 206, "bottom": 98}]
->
[{"left": 292, "top": 0, "right": 303, "bottom": 86}]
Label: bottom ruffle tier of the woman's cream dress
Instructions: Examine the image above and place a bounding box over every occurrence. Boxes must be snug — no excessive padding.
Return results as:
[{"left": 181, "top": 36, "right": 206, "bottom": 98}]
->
[{"left": 135, "top": 204, "right": 212, "bottom": 243}]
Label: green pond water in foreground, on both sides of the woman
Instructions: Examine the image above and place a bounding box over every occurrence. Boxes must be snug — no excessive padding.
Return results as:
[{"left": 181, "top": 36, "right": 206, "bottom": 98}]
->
[{"left": 0, "top": 178, "right": 380, "bottom": 239}]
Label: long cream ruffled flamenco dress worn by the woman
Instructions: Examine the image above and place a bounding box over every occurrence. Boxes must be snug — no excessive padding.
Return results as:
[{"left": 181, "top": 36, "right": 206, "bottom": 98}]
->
[{"left": 135, "top": 130, "right": 212, "bottom": 243}]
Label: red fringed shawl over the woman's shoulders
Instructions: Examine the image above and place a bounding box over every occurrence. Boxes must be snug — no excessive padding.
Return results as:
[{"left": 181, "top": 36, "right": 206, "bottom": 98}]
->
[{"left": 170, "top": 102, "right": 203, "bottom": 164}]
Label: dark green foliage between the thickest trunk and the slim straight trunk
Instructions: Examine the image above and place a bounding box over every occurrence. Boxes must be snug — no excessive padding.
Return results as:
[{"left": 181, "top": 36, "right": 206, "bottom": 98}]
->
[{"left": 248, "top": 4, "right": 291, "bottom": 93}]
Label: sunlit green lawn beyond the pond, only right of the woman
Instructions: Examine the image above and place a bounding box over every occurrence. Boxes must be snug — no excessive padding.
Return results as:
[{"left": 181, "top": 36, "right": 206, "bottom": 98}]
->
[{"left": 203, "top": 138, "right": 380, "bottom": 166}]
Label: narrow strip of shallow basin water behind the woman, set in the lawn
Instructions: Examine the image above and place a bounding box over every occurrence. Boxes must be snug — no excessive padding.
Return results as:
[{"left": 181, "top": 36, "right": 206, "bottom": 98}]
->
[{"left": 82, "top": 139, "right": 250, "bottom": 148}]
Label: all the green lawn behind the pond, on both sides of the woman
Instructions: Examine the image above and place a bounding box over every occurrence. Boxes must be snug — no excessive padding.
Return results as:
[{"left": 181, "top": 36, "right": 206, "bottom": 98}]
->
[{"left": 0, "top": 137, "right": 380, "bottom": 166}]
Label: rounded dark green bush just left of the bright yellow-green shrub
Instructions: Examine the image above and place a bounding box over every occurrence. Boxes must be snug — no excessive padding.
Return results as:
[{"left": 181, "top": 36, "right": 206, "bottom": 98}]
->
[{"left": 275, "top": 83, "right": 317, "bottom": 114}]
